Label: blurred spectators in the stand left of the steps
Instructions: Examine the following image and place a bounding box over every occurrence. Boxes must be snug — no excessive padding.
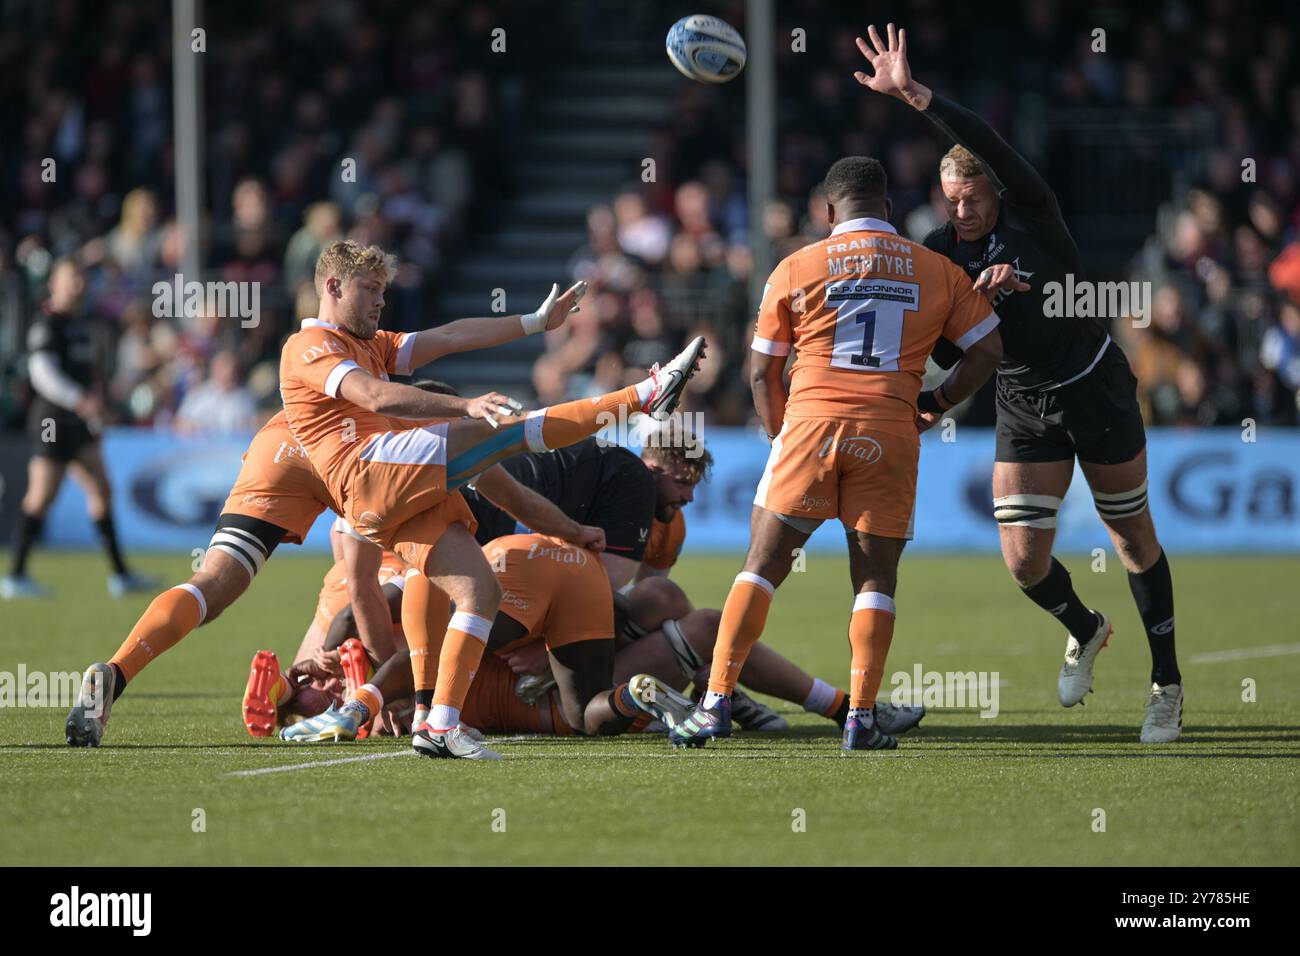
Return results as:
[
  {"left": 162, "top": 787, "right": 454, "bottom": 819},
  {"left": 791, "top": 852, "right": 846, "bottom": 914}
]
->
[{"left": 0, "top": 0, "right": 536, "bottom": 431}]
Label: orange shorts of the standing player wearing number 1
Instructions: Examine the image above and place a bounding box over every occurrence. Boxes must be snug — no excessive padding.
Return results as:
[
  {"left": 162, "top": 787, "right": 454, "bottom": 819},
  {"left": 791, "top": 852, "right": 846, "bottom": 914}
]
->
[{"left": 754, "top": 416, "right": 920, "bottom": 538}]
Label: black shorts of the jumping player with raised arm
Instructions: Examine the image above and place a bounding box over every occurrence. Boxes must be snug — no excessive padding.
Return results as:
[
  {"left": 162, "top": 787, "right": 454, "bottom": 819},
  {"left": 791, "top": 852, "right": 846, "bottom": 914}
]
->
[{"left": 997, "top": 342, "right": 1147, "bottom": 464}]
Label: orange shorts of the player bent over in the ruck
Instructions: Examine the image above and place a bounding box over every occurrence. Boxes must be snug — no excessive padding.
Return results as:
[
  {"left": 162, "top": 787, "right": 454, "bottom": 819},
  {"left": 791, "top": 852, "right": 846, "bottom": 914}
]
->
[{"left": 484, "top": 535, "right": 614, "bottom": 652}]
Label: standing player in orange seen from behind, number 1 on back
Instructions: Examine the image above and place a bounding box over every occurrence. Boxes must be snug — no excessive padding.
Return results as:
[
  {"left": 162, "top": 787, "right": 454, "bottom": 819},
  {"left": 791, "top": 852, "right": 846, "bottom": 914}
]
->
[{"left": 670, "top": 156, "right": 1002, "bottom": 750}]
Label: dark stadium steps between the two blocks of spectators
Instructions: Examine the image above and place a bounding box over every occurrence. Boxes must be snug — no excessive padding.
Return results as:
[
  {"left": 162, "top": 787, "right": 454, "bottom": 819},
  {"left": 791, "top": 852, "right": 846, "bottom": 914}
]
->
[{"left": 424, "top": 57, "right": 683, "bottom": 401}]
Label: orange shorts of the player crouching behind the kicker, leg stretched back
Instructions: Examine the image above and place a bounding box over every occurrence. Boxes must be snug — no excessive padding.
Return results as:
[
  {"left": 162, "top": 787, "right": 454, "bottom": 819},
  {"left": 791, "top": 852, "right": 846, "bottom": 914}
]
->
[{"left": 220, "top": 421, "right": 329, "bottom": 545}]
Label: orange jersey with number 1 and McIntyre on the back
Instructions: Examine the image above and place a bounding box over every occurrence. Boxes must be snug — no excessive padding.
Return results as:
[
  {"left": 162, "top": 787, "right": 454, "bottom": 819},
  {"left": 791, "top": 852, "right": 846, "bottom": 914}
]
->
[{"left": 753, "top": 219, "right": 998, "bottom": 421}]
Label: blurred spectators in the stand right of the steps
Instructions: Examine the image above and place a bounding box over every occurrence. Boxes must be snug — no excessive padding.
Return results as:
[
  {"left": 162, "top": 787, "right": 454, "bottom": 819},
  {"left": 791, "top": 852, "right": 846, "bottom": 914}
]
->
[{"left": 534, "top": 0, "right": 1300, "bottom": 425}]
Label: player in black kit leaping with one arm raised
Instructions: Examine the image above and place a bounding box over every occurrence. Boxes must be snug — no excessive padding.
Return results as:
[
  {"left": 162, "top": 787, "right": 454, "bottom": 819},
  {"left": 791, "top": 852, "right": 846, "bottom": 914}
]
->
[{"left": 854, "top": 23, "right": 1183, "bottom": 743}]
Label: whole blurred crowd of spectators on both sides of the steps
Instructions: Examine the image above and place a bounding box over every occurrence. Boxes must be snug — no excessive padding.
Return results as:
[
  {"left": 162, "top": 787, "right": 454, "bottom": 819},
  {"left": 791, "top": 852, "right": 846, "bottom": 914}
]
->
[{"left": 0, "top": 0, "right": 1300, "bottom": 429}]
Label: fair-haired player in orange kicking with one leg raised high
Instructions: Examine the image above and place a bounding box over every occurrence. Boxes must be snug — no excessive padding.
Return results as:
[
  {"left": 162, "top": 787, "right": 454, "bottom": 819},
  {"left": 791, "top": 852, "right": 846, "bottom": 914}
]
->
[{"left": 280, "top": 241, "right": 705, "bottom": 760}]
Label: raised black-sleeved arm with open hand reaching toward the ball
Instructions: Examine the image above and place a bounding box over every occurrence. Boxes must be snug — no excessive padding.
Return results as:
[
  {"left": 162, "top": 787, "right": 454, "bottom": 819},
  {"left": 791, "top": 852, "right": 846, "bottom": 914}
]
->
[{"left": 853, "top": 23, "right": 1056, "bottom": 213}]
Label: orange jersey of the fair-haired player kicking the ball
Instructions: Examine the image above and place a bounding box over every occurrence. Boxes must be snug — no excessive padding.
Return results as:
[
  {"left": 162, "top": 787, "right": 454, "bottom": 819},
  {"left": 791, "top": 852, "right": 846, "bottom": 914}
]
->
[{"left": 280, "top": 319, "right": 420, "bottom": 505}]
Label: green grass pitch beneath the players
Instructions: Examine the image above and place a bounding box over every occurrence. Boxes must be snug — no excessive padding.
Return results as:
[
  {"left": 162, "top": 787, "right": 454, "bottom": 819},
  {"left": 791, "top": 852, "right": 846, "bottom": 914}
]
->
[{"left": 0, "top": 548, "right": 1300, "bottom": 866}]
